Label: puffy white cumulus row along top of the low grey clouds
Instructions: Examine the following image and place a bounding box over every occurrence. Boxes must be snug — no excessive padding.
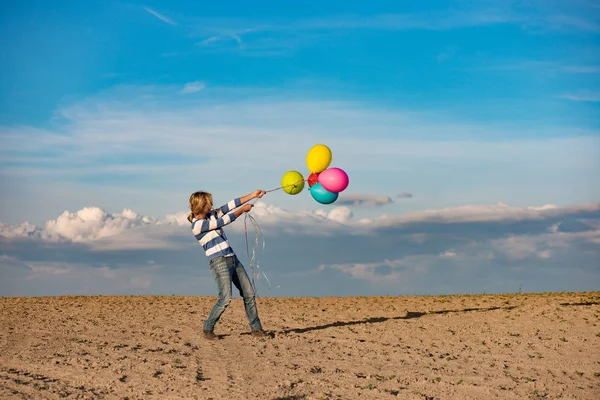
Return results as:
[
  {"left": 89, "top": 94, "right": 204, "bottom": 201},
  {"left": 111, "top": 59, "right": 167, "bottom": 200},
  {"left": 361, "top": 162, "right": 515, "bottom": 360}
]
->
[{"left": 0, "top": 202, "right": 600, "bottom": 250}]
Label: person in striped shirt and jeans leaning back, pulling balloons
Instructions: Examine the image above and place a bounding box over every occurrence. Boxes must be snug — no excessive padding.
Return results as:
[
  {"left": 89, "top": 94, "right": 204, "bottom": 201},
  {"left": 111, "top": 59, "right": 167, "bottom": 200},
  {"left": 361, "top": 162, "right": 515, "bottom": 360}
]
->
[{"left": 188, "top": 190, "right": 267, "bottom": 340}]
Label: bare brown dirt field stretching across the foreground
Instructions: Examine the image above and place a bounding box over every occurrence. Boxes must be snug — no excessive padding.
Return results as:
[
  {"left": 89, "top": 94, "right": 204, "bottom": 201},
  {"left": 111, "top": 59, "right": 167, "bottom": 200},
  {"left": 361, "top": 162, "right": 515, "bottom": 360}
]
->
[{"left": 0, "top": 292, "right": 600, "bottom": 400}]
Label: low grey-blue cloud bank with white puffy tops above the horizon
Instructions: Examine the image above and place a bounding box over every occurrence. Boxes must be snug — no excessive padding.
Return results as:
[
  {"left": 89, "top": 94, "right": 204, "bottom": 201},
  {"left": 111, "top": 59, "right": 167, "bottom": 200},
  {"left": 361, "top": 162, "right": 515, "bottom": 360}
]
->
[{"left": 0, "top": 202, "right": 600, "bottom": 296}]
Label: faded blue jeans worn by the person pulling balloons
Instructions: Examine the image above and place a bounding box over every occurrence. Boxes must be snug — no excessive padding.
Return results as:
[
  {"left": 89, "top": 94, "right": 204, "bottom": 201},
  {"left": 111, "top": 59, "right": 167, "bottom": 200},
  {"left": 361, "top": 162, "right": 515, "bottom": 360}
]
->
[{"left": 204, "top": 256, "right": 262, "bottom": 331}]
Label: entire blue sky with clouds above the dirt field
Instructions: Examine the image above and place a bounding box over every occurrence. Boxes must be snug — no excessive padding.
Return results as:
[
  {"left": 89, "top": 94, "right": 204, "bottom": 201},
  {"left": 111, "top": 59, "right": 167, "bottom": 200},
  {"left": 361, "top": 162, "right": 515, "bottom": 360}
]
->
[{"left": 0, "top": 0, "right": 600, "bottom": 295}]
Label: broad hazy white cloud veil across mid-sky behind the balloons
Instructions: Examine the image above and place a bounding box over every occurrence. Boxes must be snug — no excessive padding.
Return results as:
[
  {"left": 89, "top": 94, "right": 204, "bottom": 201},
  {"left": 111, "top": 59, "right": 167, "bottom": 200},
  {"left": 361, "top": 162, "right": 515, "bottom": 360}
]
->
[{"left": 0, "top": 85, "right": 600, "bottom": 227}]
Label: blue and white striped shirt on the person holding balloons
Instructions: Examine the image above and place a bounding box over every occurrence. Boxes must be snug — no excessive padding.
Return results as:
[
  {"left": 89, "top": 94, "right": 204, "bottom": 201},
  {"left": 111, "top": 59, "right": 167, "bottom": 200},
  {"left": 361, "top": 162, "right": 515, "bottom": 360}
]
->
[{"left": 192, "top": 197, "right": 242, "bottom": 261}]
